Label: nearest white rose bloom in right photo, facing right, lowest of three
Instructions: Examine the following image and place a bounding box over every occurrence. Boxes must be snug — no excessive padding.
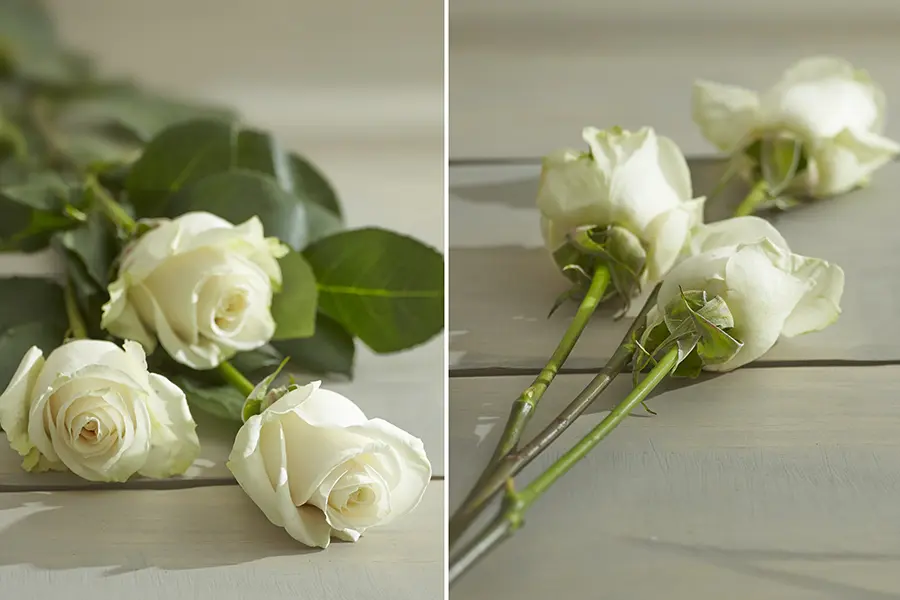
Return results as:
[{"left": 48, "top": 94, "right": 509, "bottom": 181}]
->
[{"left": 648, "top": 217, "right": 844, "bottom": 371}]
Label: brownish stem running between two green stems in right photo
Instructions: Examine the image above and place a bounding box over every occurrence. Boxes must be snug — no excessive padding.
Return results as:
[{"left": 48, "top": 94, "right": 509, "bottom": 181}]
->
[{"left": 449, "top": 285, "right": 659, "bottom": 545}]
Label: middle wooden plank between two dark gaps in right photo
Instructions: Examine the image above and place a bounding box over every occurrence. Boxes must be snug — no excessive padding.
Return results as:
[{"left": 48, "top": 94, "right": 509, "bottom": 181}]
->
[{"left": 450, "top": 160, "right": 900, "bottom": 369}]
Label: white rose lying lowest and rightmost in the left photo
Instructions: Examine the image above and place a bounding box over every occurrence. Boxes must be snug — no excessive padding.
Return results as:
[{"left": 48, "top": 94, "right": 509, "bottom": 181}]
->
[{"left": 228, "top": 382, "right": 431, "bottom": 548}]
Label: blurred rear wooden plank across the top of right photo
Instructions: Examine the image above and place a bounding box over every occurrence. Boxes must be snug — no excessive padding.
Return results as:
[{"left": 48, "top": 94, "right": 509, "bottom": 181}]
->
[{"left": 449, "top": 14, "right": 900, "bottom": 158}]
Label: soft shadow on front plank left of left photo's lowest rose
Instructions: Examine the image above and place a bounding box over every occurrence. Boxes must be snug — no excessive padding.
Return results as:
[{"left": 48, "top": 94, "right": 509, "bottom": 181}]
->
[{"left": 0, "top": 486, "right": 318, "bottom": 575}]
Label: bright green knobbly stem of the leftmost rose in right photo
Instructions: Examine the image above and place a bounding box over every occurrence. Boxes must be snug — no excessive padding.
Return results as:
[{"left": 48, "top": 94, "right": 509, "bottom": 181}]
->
[{"left": 487, "top": 265, "right": 610, "bottom": 470}]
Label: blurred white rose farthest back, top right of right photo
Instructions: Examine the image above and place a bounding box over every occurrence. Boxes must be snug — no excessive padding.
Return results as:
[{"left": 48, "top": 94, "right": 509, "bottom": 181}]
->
[{"left": 693, "top": 56, "right": 900, "bottom": 196}]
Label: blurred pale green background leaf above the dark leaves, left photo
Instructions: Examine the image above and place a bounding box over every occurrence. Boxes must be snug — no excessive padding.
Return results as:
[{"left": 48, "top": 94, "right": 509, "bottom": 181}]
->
[{"left": 57, "top": 83, "right": 234, "bottom": 142}]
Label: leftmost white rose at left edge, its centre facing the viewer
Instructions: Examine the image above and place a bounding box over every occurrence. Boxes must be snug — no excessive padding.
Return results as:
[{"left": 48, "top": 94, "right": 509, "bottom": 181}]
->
[{"left": 0, "top": 340, "right": 200, "bottom": 481}]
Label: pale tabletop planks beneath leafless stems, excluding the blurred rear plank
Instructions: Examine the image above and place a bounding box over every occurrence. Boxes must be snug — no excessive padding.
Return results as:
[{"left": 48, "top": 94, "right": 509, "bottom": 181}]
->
[{"left": 449, "top": 160, "right": 900, "bottom": 600}]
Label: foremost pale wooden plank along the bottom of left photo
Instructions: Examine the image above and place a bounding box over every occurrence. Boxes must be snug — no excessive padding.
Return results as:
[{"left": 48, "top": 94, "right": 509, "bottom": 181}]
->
[{"left": 0, "top": 482, "right": 444, "bottom": 600}]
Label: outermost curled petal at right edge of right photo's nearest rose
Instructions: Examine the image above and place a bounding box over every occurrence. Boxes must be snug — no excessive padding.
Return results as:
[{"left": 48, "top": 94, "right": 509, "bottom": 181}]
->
[{"left": 781, "top": 254, "right": 844, "bottom": 337}]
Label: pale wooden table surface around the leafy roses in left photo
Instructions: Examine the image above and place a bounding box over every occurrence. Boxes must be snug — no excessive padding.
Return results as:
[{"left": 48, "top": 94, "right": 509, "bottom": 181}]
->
[{"left": 0, "top": 0, "right": 445, "bottom": 600}]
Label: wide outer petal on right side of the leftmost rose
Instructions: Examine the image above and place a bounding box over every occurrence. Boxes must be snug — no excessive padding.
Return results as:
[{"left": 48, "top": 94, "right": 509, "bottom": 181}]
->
[{"left": 140, "top": 373, "right": 200, "bottom": 478}]
